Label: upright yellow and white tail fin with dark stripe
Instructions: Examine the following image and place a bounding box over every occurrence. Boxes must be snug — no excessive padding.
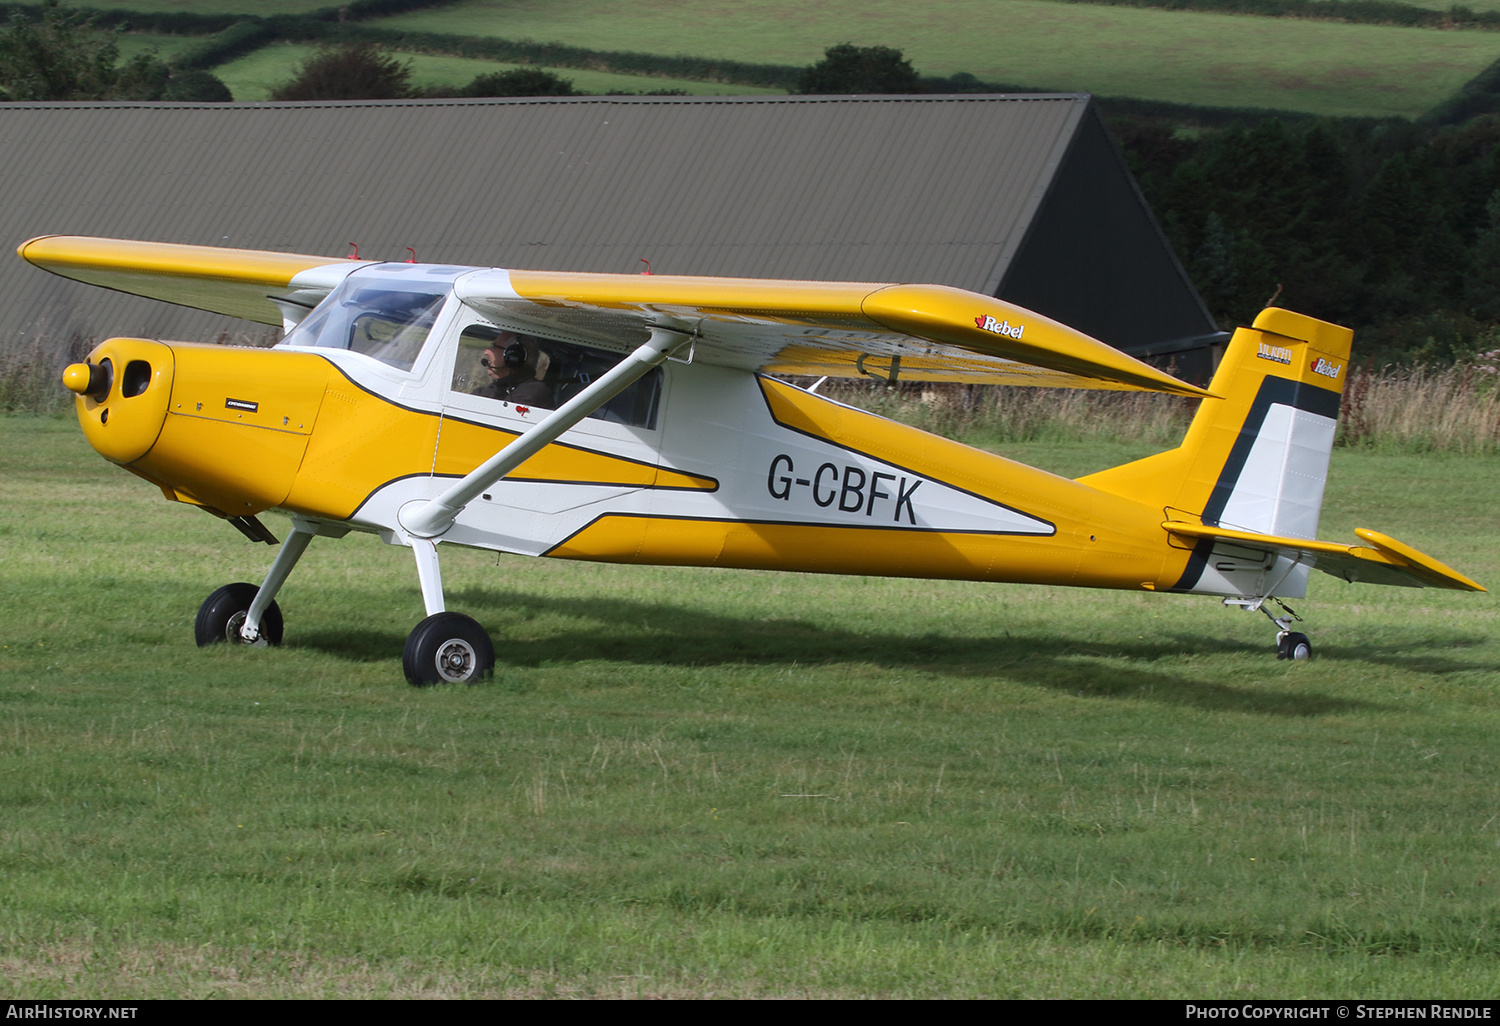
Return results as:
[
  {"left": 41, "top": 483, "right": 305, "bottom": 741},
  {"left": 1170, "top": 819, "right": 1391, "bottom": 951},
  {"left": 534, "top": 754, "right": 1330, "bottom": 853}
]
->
[{"left": 1080, "top": 308, "right": 1353, "bottom": 597}]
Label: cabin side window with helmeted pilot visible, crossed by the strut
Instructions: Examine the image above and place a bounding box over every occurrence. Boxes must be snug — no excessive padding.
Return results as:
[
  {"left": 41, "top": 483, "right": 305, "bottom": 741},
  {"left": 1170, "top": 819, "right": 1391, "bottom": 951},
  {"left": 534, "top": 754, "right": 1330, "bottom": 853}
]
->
[{"left": 453, "top": 324, "right": 662, "bottom": 429}]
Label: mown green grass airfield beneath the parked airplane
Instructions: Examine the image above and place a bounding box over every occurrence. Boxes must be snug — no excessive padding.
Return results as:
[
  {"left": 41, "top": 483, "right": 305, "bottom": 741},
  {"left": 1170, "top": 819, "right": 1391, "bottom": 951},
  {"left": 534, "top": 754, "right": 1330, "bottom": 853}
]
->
[{"left": 0, "top": 417, "right": 1500, "bottom": 998}]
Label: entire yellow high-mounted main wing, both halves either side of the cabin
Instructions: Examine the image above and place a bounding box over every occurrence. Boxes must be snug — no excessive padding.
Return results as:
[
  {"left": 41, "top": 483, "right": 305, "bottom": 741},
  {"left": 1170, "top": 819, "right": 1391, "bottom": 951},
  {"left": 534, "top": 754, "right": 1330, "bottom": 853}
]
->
[{"left": 18, "top": 236, "right": 1212, "bottom": 398}]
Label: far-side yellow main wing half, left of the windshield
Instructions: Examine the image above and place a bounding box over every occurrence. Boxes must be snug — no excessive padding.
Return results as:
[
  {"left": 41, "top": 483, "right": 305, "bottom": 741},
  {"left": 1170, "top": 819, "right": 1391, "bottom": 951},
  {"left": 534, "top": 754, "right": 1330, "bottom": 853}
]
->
[{"left": 17, "top": 236, "right": 360, "bottom": 324}]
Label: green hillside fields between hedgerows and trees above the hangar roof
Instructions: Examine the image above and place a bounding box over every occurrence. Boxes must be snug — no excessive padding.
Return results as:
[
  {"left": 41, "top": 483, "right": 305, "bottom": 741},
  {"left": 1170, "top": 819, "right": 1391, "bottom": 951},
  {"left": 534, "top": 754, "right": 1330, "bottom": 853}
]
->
[{"left": 32, "top": 0, "right": 1500, "bottom": 117}]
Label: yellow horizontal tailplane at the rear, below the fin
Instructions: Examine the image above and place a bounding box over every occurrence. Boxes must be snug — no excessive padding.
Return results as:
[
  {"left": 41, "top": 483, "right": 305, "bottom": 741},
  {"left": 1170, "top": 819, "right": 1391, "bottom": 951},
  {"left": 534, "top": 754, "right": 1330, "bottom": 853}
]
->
[{"left": 1161, "top": 521, "right": 1485, "bottom": 591}]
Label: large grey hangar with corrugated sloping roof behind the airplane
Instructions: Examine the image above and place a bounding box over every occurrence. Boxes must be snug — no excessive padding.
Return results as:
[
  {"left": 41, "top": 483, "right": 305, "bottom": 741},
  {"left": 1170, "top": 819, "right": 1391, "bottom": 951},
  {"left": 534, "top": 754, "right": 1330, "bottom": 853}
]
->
[{"left": 0, "top": 95, "right": 1224, "bottom": 365}]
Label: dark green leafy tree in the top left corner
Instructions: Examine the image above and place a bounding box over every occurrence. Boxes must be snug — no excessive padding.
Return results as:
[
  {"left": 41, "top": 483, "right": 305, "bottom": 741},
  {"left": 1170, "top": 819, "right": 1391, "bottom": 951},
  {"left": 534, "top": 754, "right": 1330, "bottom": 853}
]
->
[{"left": 0, "top": 0, "right": 170, "bottom": 102}]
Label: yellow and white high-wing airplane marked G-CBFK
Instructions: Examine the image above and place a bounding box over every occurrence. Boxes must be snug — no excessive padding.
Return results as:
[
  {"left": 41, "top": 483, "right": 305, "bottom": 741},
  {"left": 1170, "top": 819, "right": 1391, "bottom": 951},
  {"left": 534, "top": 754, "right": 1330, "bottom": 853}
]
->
[{"left": 20, "top": 236, "right": 1484, "bottom": 686}]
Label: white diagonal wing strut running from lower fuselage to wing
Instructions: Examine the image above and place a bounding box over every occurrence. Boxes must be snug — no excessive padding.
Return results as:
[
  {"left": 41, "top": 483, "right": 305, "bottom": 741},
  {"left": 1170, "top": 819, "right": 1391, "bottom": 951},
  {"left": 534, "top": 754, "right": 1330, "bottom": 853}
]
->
[{"left": 396, "top": 324, "right": 692, "bottom": 539}]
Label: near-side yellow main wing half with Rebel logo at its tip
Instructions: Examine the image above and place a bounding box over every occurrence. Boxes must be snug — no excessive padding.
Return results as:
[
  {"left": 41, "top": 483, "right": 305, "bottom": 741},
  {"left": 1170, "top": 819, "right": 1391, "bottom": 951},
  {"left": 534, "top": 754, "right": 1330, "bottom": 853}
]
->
[{"left": 458, "top": 270, "right": 1212, "bottom": 398}]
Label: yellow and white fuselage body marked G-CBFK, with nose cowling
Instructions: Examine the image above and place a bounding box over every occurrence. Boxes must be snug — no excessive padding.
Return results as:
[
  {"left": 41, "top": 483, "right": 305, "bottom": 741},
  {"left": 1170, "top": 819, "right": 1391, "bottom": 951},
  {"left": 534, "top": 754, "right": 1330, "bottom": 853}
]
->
[{"left": 70, "top": 327, "right": 1188, "bottom": 590}]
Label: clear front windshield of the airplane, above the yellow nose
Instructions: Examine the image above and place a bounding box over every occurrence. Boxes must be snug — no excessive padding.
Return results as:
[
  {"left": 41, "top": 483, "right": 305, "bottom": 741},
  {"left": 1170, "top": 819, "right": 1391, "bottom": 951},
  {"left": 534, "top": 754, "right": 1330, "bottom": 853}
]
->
[{"left": 282, "top": 264, "right": 464, "bottom": 371}]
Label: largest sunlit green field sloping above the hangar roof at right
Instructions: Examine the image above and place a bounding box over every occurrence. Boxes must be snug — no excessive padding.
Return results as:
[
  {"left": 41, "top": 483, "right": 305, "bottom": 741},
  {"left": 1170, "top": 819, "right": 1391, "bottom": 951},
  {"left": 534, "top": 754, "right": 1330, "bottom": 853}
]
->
[{"left": 369, "top": 0, "right": 1500, "bottom": 116}]
